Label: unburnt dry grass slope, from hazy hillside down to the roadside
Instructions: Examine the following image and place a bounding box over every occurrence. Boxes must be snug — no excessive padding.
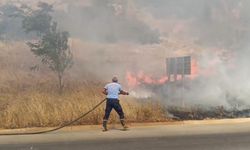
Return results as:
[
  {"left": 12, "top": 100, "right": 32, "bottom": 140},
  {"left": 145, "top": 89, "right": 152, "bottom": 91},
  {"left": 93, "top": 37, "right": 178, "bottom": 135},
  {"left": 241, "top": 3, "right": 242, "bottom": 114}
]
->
[{"left": 0, "top": 43, "right": 167, "bottom": 128}]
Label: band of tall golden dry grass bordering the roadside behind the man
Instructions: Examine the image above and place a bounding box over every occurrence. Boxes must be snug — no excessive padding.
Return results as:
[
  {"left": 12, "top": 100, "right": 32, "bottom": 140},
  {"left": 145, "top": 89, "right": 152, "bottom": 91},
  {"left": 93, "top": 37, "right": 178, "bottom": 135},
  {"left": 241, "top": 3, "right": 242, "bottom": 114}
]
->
[{"left": 0, "top": 85, "right": 166, "bottom": 128}]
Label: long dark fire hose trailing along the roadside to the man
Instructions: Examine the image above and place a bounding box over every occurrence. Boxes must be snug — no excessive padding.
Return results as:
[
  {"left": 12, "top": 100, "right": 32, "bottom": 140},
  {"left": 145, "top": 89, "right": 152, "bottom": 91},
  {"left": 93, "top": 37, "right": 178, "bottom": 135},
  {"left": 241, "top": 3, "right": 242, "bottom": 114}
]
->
[{"left": 0, "top": 99, "right": 106, "bottom": 136}]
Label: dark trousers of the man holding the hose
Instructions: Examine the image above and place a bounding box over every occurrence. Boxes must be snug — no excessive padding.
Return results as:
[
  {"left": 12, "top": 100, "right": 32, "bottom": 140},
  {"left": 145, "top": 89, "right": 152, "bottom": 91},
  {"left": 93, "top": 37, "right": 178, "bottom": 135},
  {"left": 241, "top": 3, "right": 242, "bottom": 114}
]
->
[{"left": 103, "top": 99, "right": 124, "bottom": 121}]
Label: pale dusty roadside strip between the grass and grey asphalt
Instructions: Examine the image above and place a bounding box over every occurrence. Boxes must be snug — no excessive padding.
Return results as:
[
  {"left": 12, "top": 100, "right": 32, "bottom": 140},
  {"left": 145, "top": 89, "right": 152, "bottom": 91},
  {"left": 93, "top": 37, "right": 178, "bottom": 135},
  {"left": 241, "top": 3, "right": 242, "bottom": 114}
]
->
[{"left": 0, "top": 118, "right": 250, "bottom": 145}]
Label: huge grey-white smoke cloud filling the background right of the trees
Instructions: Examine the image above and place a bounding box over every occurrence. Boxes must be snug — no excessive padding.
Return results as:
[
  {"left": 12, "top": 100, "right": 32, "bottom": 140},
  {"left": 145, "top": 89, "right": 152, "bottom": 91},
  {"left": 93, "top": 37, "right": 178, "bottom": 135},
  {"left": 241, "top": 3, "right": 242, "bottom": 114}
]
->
[{"left": 1, "top": 0, "right": 250, "bottom": 108}]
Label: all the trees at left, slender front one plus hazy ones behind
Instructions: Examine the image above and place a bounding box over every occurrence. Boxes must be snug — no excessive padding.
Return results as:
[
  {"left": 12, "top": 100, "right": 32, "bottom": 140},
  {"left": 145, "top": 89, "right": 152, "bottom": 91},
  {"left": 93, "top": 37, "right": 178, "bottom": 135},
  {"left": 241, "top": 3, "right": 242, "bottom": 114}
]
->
[{"left": 0, "top": 2, "right": 73, "bottom": 93}]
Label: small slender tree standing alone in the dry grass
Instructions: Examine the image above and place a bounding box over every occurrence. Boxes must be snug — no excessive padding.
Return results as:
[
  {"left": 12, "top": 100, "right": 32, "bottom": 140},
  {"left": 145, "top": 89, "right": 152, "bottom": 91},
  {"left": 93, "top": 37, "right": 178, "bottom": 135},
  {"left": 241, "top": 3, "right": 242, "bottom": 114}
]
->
[{"left": 28, "top": 23, "right": 73, "bottom": 92}]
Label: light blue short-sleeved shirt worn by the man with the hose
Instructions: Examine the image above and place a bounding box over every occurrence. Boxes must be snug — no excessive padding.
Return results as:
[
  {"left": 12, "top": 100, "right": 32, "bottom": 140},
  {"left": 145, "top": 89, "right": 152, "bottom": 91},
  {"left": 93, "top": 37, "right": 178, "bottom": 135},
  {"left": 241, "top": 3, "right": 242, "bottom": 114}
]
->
[{"left": 104, "top": 82, "right": 122, "bottom": 99}]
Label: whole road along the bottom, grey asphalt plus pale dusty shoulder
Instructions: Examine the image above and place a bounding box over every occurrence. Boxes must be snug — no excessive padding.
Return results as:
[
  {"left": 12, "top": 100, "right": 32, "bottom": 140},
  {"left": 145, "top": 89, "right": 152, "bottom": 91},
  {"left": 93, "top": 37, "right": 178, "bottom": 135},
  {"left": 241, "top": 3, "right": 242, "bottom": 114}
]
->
[{"left": 0, "top": 119, "right": 250, "bottom": 150}]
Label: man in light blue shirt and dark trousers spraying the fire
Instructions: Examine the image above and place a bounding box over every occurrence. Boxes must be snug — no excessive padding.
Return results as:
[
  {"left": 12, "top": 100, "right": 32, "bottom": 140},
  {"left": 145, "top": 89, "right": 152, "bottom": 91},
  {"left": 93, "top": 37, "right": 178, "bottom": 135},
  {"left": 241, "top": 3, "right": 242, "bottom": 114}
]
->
[{"left": 103, "top": 77, "right": 129, "bottom": 131}]
